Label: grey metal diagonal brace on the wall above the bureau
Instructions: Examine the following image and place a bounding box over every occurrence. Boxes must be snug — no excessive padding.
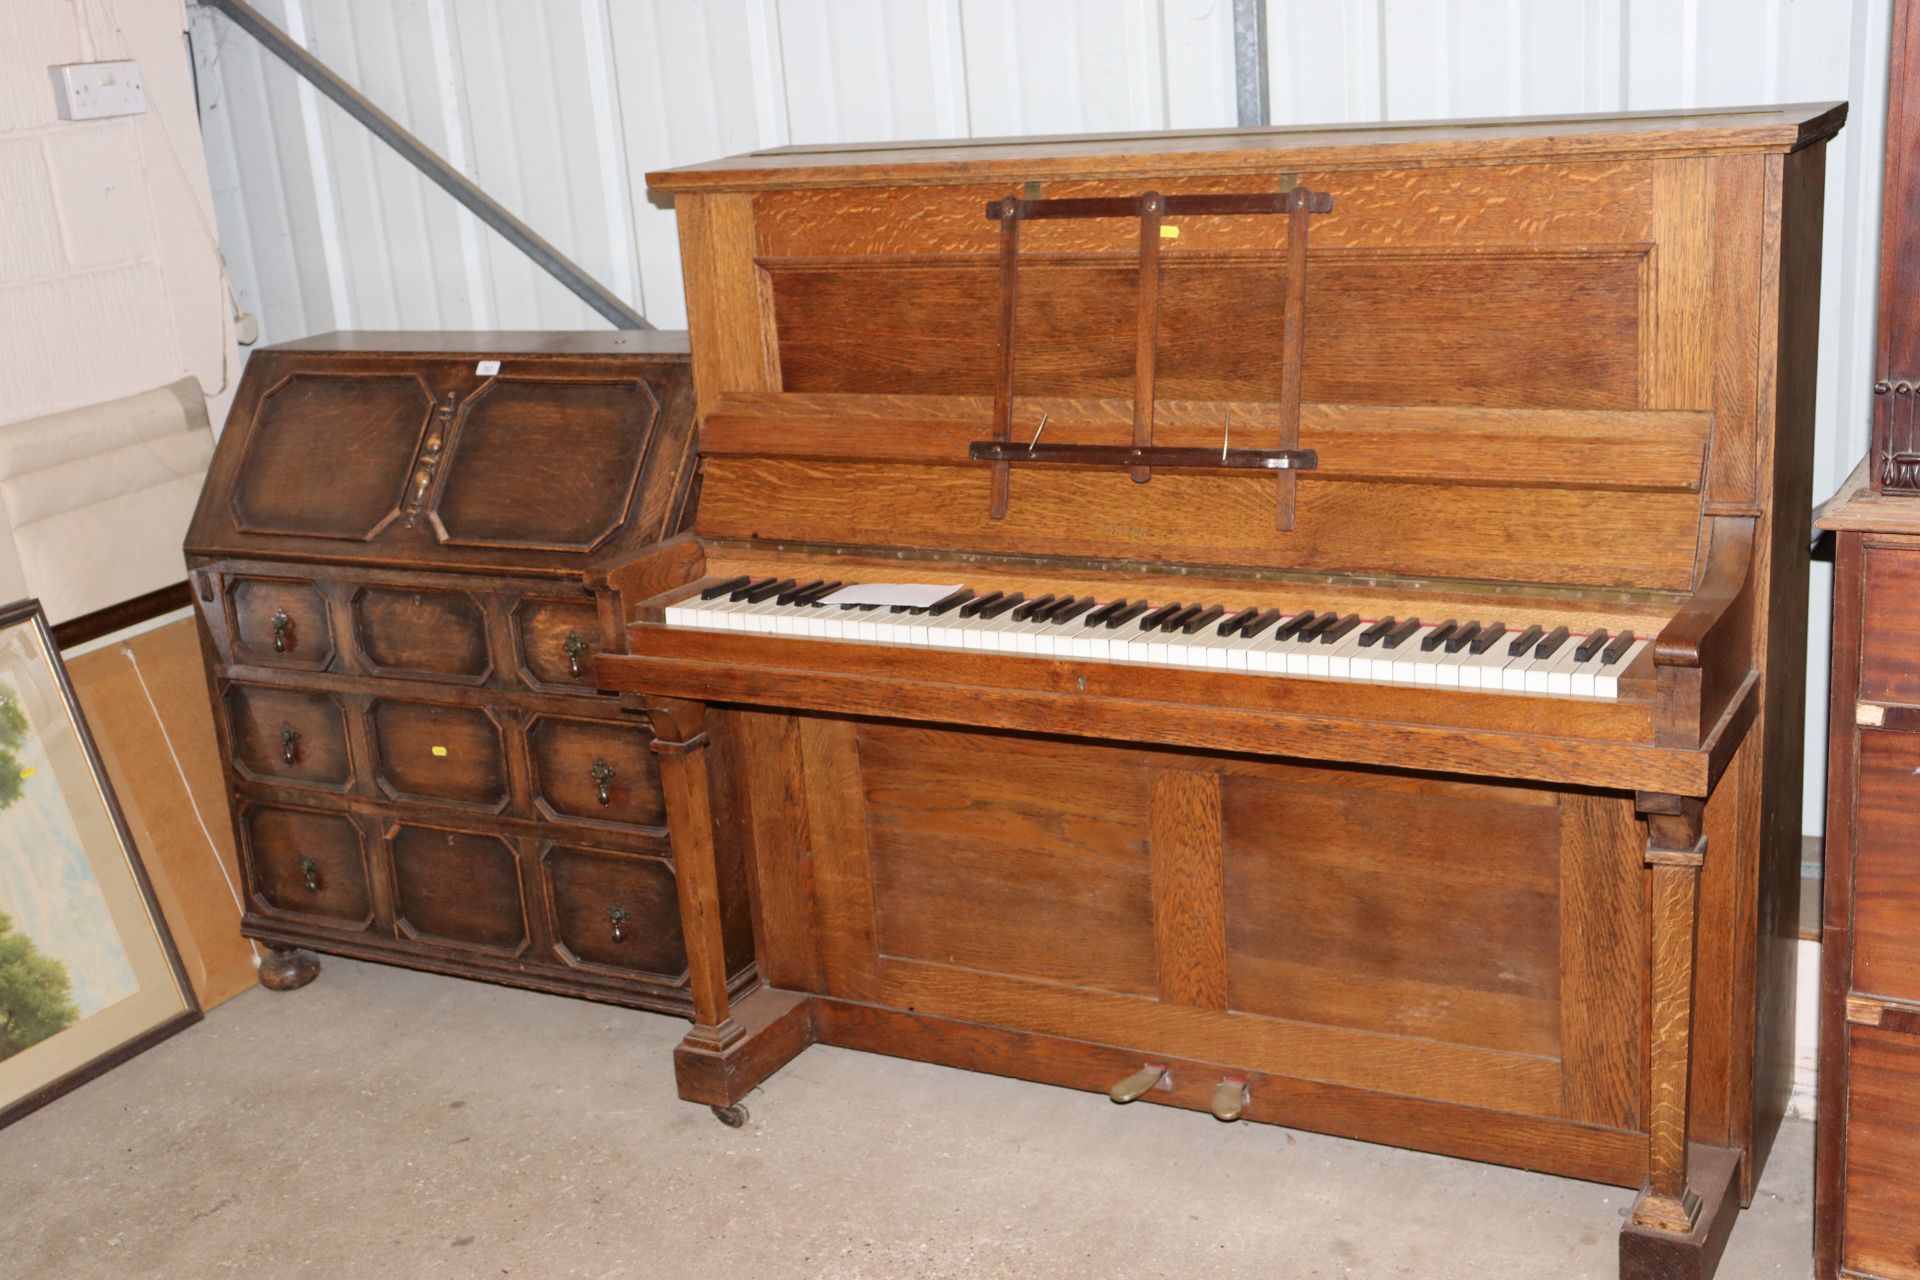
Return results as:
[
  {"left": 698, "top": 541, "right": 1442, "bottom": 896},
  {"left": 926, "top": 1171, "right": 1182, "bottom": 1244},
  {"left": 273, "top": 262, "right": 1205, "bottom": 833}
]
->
[{"left": 200, "top": 0, "right": 653, "bottom": 328}]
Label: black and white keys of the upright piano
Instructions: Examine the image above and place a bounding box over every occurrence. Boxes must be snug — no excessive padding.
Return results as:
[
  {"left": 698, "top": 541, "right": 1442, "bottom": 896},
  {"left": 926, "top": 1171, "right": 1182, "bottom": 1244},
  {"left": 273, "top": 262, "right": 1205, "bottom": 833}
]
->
[{"left": 666, "top": 578, "right": 1647, "bottom": 699}]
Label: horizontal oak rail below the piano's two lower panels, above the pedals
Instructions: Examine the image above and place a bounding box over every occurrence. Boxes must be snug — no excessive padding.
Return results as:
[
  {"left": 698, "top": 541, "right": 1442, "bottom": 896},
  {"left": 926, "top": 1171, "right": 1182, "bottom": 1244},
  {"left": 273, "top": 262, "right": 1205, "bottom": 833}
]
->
[{"left": 881, "top": 960, "right": 1561, "bottom": 1117}]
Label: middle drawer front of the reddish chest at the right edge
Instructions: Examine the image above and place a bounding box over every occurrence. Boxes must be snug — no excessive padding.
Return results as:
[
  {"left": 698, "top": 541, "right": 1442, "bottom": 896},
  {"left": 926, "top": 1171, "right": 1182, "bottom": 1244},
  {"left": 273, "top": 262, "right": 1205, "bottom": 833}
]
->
[{"left": 1853, "top": 729, "right": 1920, "bottom": 1000}]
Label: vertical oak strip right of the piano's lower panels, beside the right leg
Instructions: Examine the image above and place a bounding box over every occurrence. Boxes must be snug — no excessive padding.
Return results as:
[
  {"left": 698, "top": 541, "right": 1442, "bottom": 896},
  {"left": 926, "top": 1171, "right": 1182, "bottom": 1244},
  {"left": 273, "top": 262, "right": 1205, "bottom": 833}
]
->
[{"left": 1559, "top": 791, "right": 1647, "bottom": 1128}]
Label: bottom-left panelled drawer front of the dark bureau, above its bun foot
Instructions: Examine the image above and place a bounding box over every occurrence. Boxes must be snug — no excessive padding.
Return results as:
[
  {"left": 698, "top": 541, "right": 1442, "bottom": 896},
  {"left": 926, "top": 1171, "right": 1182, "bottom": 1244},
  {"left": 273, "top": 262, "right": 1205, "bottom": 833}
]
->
[{"left": 240, "top": 804, "right": 372, "bottom": 929}]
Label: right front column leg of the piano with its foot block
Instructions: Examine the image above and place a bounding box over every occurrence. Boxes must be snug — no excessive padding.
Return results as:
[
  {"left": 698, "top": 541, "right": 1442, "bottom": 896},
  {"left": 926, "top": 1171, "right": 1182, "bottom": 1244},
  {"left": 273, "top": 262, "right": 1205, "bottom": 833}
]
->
[{"left": 1620, "top": 794, "right": 1740, "bottom": 1280}]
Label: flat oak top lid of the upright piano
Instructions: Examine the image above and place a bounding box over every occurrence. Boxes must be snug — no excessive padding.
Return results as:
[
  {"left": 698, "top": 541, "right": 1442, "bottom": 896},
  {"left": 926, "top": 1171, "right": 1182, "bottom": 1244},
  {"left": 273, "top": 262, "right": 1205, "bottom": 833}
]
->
[{"left": 647, "top": 102, "right": 1847, "bottom": 192}]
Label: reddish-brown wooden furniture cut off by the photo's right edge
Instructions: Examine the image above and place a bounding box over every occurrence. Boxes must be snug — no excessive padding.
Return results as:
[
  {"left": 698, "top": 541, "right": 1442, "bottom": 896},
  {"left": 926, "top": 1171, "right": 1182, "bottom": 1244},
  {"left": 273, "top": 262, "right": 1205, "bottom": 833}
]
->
[{"left": 1814, "top": 0, "right": 1920, "bottom": 1280}]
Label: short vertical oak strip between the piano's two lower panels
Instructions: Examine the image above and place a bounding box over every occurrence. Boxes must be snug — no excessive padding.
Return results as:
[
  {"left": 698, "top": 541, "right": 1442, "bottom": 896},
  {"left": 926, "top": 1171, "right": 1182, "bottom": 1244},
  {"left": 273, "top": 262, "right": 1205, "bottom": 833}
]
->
[{"left": 1146, "top": 766, "right": 1229, "bottom": 1009}]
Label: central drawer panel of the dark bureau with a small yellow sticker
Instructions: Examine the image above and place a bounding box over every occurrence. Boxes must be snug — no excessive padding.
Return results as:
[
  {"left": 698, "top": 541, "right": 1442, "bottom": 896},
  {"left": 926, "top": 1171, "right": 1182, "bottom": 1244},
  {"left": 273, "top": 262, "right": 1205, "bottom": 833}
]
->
[{"left": 367, "top": 699, "right": 513, "bottom": 812}]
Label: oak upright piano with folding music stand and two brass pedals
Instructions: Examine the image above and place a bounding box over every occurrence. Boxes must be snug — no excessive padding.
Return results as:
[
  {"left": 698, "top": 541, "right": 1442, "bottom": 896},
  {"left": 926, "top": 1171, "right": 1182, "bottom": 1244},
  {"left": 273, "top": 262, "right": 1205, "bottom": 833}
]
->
[{"left": 593, "top": 104, "right": 1845, "bottom": 1278}]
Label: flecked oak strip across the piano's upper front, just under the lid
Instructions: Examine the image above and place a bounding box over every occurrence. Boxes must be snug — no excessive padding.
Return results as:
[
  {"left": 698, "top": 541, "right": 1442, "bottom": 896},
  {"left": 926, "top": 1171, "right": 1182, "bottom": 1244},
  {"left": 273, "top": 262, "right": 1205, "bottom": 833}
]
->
[{"left": 753, "top": 163, "right": 1653, "bottom": 261}]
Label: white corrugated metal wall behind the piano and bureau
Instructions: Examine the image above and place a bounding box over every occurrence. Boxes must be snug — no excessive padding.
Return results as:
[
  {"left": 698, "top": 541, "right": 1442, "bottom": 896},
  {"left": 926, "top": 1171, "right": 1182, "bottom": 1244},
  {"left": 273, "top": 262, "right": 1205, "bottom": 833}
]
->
[{"left": 194, "top": 0, "right": 1891, "bottom": 831}]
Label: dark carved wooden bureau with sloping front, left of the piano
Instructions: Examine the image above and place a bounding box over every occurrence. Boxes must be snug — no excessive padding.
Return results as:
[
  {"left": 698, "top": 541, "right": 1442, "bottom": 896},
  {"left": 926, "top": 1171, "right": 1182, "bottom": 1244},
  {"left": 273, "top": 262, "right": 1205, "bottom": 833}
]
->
[{"left": 186, "top": 332, "right": 753, "bottom": 1013}]
